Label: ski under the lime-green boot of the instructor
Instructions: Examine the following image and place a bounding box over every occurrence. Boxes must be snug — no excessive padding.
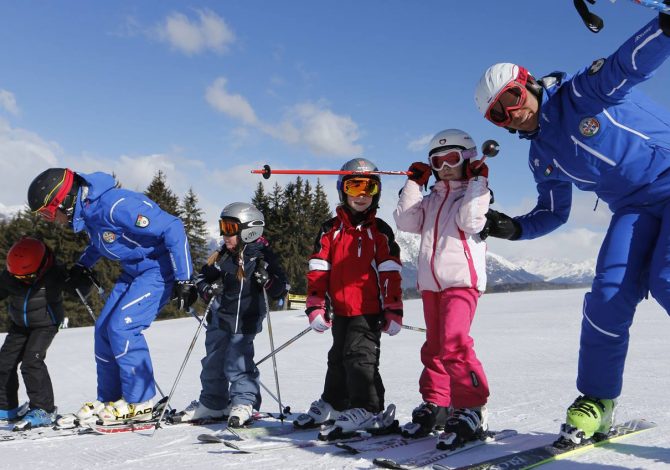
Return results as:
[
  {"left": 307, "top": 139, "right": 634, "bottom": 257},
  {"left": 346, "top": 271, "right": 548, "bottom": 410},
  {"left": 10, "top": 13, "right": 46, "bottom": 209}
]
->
[{"left": 448, "top": 419, "right": 656, "bottom": 470}]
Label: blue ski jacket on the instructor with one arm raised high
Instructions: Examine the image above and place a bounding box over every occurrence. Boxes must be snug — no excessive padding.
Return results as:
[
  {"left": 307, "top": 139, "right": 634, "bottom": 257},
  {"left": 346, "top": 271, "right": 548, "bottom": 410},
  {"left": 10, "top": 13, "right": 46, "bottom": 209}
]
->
[{"left": 515, "top": 18, "right": 670, "bottom": 239}]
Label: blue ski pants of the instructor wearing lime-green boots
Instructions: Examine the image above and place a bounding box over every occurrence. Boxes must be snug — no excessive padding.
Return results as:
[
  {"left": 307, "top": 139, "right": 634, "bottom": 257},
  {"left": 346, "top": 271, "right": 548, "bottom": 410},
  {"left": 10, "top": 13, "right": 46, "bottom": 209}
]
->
[{"left": 577, "top": 201, "right": 670, "bottom": 399}]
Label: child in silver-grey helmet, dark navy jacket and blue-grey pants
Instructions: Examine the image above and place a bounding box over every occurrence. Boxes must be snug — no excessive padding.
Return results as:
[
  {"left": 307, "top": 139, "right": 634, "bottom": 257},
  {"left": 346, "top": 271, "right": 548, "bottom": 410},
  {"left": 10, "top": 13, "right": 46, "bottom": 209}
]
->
[{"left": 173, "top": 202, "right": 288, "bottom": 427}]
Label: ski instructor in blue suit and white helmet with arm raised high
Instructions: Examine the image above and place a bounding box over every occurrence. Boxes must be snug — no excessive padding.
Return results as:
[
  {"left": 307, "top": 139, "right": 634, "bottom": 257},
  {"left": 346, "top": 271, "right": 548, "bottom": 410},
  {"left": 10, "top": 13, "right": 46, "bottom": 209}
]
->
[{"left": 475, "top": 11, "right": 670, "bottom": 443}]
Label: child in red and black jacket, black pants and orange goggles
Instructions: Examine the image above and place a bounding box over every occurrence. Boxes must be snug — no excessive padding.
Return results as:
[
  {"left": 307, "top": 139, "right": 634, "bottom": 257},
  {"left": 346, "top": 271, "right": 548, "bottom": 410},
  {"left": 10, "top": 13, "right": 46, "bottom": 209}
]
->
[{"left": 293, "top": 158, "right": 403, "bottom": 439}]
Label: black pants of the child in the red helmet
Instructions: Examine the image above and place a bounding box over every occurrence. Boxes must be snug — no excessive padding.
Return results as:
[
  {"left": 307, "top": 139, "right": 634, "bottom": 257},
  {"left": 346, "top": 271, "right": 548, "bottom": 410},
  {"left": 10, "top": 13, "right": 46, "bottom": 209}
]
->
[{"left": 0, "top": 323, "right": 58, "bottom": 412}]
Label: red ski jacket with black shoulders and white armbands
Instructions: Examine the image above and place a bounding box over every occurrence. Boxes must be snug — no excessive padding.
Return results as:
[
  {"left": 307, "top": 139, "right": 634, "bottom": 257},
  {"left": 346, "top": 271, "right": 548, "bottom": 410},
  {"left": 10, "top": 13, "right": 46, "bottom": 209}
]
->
[{"left": 307, "top": 206, "right": 402, "bottom": 317}]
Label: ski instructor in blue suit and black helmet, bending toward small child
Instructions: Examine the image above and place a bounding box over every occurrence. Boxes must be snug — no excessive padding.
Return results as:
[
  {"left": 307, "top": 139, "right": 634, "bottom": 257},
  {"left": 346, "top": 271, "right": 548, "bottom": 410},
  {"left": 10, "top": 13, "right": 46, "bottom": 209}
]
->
[{"left": 28, "top": 168, "right": 197, "bottom": 423}]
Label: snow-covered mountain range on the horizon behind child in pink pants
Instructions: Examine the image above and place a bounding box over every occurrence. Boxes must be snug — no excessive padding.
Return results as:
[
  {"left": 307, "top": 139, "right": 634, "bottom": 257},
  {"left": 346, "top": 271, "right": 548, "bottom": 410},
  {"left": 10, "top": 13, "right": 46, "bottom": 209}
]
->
[{"left": 396, "top": 232, "right": 594, "bottom": 289}]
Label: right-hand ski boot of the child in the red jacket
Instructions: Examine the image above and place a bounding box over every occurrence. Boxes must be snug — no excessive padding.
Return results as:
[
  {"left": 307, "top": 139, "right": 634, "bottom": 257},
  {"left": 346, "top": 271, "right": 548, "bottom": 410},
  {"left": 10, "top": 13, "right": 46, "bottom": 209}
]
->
[{"left": 318, "top": 404, "right": 399, "bottom": 441}]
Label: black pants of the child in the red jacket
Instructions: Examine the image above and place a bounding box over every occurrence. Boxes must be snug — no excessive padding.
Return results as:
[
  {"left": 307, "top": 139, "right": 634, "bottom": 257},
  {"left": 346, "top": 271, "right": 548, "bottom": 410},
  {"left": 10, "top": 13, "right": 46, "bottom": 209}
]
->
[{"left": 322, "top": 315, "right": 384, "bottom": 413}]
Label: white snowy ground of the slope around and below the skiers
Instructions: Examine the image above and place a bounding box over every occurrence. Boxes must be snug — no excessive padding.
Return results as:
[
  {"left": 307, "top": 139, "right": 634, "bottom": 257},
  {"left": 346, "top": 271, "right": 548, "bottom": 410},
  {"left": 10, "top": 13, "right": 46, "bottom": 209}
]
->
[{"left": 0, "top": 290, "right": 670, "bottom": 470}]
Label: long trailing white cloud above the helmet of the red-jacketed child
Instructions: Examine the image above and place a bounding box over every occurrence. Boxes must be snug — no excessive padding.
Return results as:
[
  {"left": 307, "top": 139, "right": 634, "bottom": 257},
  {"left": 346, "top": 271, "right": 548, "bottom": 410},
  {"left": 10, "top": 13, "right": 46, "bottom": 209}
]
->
[{"left": 205, "top": 77, "right": 363, "bottom": 156}]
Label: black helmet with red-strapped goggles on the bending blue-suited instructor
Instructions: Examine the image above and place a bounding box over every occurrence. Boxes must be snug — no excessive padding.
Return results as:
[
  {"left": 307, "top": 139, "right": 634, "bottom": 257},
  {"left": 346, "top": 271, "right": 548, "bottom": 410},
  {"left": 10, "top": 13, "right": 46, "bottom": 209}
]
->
[{"left": 28, "top": 168, "right": 80, "bottom": 222}]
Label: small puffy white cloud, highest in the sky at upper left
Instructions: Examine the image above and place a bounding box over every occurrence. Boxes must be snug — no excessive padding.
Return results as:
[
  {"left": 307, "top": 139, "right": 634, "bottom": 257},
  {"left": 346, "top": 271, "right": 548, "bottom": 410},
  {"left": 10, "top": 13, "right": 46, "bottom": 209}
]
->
[{"left": 157, "top": 10, "right": 235, "bottom": 55}]
